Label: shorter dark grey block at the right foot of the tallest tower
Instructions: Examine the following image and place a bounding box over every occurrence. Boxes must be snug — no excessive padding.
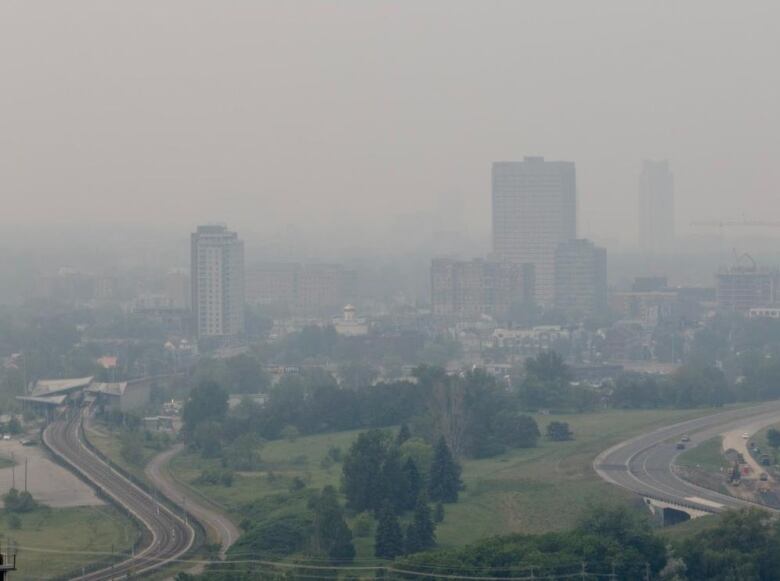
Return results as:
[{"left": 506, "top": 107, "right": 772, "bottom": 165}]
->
[{"left": 555, "top": 239, "right": 607, "bottom": 317}]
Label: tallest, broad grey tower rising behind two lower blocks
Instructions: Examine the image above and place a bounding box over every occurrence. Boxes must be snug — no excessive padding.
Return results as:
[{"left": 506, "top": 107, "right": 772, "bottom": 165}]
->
[{"left": 493, "top": 157, "right": 577, "bottom": 305}]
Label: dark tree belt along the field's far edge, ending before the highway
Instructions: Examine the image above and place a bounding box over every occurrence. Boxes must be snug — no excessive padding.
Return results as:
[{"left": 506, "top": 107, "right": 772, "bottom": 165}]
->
[{"left": 182, "top": 367, "right": 540, "bottom": 457}]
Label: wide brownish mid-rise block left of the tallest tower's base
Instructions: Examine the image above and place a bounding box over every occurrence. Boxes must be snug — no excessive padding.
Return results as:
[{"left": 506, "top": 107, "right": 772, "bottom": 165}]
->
[{"left": 431, "top": 258, "right": 534, "bottom": 319}]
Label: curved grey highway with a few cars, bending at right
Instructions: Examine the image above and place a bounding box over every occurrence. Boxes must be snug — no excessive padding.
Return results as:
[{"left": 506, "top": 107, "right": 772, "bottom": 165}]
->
[{"left": 593, "top": 401, "right": 780, "bottom": 512}]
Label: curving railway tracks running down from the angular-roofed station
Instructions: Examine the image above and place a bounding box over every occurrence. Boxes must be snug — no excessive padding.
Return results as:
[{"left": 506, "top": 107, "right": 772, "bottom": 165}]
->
[{"left": 43, "top": 410, "right": 195, "bottom": 581}]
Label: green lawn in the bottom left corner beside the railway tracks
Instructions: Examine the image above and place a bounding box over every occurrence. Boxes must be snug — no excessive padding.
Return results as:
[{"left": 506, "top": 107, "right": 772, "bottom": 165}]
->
[{"left": 0, "top": 506, "right": 138, "bottom": 581}]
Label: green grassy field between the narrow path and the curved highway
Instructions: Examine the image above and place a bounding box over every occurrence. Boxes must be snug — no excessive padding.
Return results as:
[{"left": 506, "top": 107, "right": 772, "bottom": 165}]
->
[{"left": 172, "top": 410, "right": 712, "bottom": 557}]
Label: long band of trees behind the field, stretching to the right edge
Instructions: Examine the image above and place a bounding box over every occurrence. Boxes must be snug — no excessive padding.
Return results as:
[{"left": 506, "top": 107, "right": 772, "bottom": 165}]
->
[{"left": 183, "top": 352, "right": 780, "bottom": 470}]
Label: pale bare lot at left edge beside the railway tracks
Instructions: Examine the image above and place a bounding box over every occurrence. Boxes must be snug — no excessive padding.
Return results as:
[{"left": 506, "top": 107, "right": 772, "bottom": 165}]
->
[{"left": 0, "top": 440, "right": 104, "bottom": 508}]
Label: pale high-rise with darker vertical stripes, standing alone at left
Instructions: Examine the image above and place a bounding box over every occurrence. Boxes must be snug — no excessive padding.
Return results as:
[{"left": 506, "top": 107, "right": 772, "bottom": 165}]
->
[{"left": 190, "top": 225, "right": 244, "bottom": 338}]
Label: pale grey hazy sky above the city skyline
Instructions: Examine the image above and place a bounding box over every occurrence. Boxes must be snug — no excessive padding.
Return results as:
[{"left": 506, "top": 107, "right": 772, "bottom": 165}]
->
[{"left": 0, "top": 0, "right": 780, "bottom": 251}]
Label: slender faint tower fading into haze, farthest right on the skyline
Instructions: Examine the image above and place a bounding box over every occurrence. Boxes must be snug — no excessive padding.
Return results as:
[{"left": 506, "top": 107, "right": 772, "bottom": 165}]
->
[{"left": 639, "top": 160, "right": 674, "bottom": 254}]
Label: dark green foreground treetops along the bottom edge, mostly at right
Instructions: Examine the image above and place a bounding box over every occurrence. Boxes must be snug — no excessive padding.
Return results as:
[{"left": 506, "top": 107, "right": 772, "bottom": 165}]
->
[{"left": 182, "top": 507, "right": 780, "bottom": 581}]
